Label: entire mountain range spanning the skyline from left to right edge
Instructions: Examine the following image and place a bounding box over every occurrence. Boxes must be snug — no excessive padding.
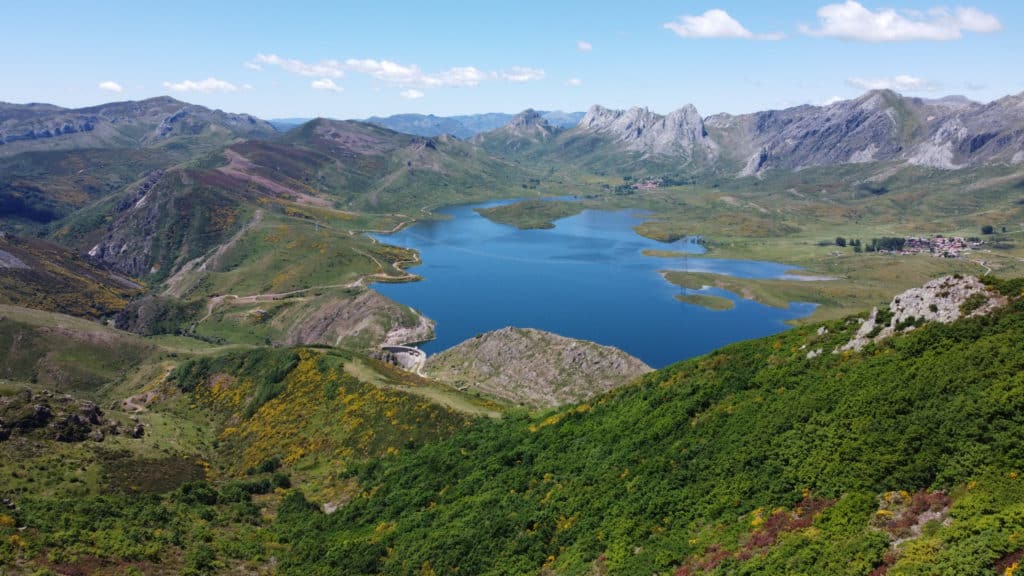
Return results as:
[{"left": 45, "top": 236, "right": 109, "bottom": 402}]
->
[{"left": 0, "top": 90, "right": 1024, "bottom": 309}]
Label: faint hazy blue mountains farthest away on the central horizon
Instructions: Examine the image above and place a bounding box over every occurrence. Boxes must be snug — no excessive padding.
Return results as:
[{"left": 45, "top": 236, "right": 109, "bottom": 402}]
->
[{"left": 367, "top": 111, "right": 584, "bottom": 139}]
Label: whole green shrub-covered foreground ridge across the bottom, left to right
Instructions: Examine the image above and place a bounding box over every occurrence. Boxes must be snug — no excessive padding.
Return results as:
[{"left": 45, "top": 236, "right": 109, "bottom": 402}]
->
[{"left": 6, "top": 279, "right": 1024, "bottom": 575}]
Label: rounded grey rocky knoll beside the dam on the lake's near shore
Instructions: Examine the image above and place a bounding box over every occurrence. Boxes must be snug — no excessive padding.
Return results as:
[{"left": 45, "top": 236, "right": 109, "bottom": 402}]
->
[{"left": 425, "top": 328, "right": 651, "bottom": 408}]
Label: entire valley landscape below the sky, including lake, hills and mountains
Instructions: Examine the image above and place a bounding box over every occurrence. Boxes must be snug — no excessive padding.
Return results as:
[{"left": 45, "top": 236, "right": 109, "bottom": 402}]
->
[{"left": 0, "top": 86, "right": 1024, "bottom": 576}]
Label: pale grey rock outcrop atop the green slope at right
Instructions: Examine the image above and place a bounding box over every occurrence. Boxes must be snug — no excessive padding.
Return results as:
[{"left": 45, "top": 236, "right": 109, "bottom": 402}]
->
[{"left": 837, "top": 276, "right": 1006, "bottom": 352}]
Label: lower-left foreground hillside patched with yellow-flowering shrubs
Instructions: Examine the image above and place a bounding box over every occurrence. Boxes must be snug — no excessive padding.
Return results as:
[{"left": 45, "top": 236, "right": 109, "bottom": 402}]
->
[{"left": 0, "top": 338, "right": 495, "bottom": 575}]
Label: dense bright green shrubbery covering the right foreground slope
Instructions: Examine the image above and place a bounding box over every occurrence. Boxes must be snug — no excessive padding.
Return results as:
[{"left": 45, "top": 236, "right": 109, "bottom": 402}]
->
[{"left": 276, "top": 297, "right": 1024, "bottom": 575}]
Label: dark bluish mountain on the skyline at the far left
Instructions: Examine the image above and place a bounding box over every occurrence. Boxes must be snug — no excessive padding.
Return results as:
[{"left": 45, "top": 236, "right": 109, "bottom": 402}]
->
[{"left": 0, "top": 97, "right": 276, "bottom": 232}]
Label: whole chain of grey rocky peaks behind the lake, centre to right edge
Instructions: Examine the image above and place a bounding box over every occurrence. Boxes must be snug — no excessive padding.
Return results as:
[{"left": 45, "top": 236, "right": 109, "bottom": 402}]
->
[{"left": 476, "top": 90, "right": 1024, "bottom": 175}]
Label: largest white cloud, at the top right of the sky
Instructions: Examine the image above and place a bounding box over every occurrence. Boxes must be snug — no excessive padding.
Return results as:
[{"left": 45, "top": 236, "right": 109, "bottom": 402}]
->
[{"left": 800, "top": 0, "right": 1002, "bottom": 42}]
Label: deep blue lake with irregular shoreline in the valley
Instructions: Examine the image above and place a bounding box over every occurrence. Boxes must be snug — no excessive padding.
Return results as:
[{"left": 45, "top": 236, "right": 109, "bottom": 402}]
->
[{"left": 374, "top": 201, "right": 814, "bottom": 368}]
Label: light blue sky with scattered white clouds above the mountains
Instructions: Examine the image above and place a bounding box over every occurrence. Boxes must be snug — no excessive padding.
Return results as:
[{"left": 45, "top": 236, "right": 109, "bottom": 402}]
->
[{"left": 0, "top": 0, "right": 1024, "bottom": 118}]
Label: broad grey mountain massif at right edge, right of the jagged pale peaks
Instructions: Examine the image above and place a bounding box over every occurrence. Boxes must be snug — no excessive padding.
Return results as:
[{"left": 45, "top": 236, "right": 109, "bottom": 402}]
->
[{"left": 706, "top": 90, "right": 1024, "bottom": 174}]
